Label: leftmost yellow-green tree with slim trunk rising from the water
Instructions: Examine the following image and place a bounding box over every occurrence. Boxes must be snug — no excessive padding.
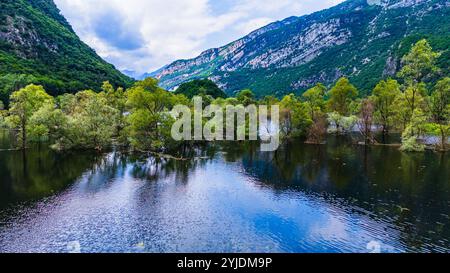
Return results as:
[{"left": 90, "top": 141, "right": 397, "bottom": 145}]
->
[{"left": 7, "top": 84, "right": 54, "bottom": 149}]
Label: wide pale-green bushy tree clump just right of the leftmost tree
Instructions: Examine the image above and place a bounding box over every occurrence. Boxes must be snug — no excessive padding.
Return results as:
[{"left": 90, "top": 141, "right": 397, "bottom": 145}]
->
[{"left": 32, "top": 90, "right": 119, "bottom": 150}]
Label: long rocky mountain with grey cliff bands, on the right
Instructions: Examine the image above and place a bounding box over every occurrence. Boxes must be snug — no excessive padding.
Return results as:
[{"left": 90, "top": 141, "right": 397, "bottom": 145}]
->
[{"left": 152, "top": 0, "right": 450, "bottom": 96}]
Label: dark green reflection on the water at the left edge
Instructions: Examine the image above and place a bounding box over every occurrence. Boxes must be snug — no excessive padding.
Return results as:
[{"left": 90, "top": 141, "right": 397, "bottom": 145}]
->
[{"left": 0, "top": 143, "right": 102, "bottom": 209}]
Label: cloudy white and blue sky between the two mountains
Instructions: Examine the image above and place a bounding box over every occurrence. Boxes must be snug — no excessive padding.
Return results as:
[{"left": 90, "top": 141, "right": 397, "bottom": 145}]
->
[{"left": 55, "top": 0, "right": 343, "bottom": 75}]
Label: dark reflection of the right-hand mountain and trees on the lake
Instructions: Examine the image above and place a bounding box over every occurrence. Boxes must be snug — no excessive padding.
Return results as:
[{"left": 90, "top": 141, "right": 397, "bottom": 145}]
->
[{"left": 237, "top": 138, "right": 450, "bottom": 251}]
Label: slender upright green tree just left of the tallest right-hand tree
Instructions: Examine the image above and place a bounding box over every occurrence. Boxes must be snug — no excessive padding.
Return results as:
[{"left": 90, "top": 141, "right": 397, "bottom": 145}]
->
[{"left": 372, "top": 79, "right": 401, "bottom": 136}]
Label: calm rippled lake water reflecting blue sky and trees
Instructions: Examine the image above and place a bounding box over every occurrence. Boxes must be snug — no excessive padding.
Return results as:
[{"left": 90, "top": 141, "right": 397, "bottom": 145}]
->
[{"left": 0, "top": 130, "right": 450, "bottom": 252}]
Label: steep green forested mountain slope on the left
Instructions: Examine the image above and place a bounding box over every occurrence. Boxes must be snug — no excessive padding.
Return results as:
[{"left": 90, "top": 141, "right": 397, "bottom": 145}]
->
[{"left": 0, "top": 0, "right": 133, "bottom": 100}]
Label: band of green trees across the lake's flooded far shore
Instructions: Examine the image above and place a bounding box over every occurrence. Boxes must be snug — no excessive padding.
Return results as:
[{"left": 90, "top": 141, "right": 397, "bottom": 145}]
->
[{"left": 0, "top": 40, "right": 450, "bottom": 153}]
